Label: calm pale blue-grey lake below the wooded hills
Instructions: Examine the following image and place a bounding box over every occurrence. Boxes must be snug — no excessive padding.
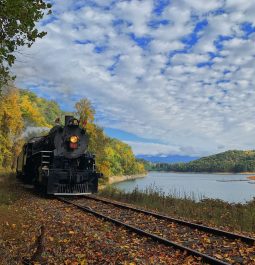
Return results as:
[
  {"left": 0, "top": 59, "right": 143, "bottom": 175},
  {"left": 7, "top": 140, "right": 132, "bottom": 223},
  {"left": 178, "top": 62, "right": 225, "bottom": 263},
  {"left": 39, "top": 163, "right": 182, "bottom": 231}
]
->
[{"left": 114, "top": 172, "right": 255, "bottom": 203}]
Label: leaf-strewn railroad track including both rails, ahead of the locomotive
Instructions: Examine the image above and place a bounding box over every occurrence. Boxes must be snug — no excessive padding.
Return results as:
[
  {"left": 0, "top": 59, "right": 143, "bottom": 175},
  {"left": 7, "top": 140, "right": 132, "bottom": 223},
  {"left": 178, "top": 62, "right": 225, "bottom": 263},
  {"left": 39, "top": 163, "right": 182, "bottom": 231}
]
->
[{"left": 58, "top": 195, "right": 255, "bottom": 265}]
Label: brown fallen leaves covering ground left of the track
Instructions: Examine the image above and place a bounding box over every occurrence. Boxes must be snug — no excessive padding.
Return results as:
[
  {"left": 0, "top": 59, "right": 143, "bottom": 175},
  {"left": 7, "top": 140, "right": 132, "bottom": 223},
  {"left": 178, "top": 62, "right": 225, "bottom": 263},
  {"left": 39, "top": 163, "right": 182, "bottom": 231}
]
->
[{"left": 0, "top": 193, "right": 202, "bottom": 265}]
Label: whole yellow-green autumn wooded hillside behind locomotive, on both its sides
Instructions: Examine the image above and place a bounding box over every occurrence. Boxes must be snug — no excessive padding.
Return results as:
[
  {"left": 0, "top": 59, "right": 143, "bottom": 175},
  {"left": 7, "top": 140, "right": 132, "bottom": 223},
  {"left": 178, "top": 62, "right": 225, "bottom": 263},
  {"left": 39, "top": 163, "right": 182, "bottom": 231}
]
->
[{"left": 0, "top": 87, "right": 145, "bottom": 179}]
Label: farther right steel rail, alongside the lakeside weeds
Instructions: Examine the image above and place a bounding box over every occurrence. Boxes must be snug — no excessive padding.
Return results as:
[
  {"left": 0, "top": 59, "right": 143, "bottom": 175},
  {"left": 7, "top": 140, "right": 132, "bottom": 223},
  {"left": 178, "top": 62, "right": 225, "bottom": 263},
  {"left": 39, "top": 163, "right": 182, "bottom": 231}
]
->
[{"left": 83, "top": 195, "right": 255, "bottom": 245}]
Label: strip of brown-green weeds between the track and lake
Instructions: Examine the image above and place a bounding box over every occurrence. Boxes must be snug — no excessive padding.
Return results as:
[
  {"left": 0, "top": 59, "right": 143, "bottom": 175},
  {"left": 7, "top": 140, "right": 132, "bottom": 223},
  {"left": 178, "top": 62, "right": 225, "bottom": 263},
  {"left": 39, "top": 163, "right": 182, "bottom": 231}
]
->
[{"left": 99, "top": 186, "right": 255, "bottom": 232}]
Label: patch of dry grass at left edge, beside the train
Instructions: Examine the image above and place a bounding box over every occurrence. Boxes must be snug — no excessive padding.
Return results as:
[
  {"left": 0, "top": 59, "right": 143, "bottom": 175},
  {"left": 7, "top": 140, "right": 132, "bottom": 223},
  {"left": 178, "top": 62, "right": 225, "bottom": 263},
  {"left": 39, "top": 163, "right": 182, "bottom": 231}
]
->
[{"left": 0, "top": 171, "right": 18, "bottom": 205}]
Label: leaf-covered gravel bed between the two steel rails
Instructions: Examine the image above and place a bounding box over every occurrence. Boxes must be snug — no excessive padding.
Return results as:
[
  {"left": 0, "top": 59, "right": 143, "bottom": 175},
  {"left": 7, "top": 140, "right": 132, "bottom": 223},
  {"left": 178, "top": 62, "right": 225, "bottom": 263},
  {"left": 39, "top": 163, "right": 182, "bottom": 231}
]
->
[{"left": 68, "top": 196, "right": 255, "bottom": 264}]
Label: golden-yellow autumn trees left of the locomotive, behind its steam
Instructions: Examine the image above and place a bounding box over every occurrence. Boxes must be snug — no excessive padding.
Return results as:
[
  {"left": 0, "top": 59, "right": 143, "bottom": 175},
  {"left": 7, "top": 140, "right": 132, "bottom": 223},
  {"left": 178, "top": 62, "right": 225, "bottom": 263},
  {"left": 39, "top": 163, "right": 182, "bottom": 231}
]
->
[{"left": 0, "top": 86, "right": 61, "bottom": 168}]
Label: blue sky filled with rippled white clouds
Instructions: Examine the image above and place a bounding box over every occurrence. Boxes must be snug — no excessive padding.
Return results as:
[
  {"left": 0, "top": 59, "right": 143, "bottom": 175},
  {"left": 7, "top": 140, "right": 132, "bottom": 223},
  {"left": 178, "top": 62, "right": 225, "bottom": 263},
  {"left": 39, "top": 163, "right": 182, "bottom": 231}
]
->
[{"left": 15, "top": 0, "right": 255, "bottom": 156}]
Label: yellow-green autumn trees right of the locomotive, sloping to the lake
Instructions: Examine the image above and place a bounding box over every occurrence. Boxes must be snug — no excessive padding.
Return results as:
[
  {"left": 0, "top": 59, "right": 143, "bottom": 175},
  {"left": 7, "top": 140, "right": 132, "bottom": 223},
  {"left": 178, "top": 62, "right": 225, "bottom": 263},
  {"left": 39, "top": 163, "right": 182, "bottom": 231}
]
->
[{"left": 75, "top": 99, "right": 145, "bottom": 179}]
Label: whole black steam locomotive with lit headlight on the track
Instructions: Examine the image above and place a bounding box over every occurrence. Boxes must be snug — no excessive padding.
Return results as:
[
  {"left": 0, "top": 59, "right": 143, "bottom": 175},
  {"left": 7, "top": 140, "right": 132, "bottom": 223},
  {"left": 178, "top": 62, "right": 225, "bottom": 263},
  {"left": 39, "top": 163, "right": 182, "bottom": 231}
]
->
[{"left": 17, "top": 116, "right": 101, "bottom": 195}]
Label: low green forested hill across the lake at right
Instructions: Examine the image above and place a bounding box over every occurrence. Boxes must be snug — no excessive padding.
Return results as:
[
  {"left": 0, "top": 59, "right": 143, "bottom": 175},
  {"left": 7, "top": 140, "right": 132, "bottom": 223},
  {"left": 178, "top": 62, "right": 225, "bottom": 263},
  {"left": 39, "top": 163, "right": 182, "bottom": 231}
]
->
[{"left": 149, "top": 150, "right": 255, "bottom": 173}]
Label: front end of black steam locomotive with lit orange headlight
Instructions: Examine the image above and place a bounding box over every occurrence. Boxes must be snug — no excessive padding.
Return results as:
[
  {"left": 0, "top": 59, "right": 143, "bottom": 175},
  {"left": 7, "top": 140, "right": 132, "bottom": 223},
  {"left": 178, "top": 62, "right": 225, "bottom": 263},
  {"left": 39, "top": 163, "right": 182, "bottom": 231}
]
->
[{"left": 45, "top": 116, "right": 100, "bottom": 195}]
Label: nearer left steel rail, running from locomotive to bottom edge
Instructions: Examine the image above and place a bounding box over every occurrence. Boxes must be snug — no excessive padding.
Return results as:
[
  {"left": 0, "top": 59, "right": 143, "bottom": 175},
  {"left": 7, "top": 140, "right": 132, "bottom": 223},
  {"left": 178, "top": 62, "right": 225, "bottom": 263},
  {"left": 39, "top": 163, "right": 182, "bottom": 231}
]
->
[{"left": 57, "top": 197, "right": 230, "bottom": 265}]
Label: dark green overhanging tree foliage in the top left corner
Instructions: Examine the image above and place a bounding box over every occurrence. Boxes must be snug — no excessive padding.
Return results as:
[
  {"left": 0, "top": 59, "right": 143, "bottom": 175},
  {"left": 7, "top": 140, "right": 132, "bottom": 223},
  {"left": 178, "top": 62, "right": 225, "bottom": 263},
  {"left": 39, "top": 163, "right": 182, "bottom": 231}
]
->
[{"left": 0, "top": 0, "right": 51, "bottom": 90}]
